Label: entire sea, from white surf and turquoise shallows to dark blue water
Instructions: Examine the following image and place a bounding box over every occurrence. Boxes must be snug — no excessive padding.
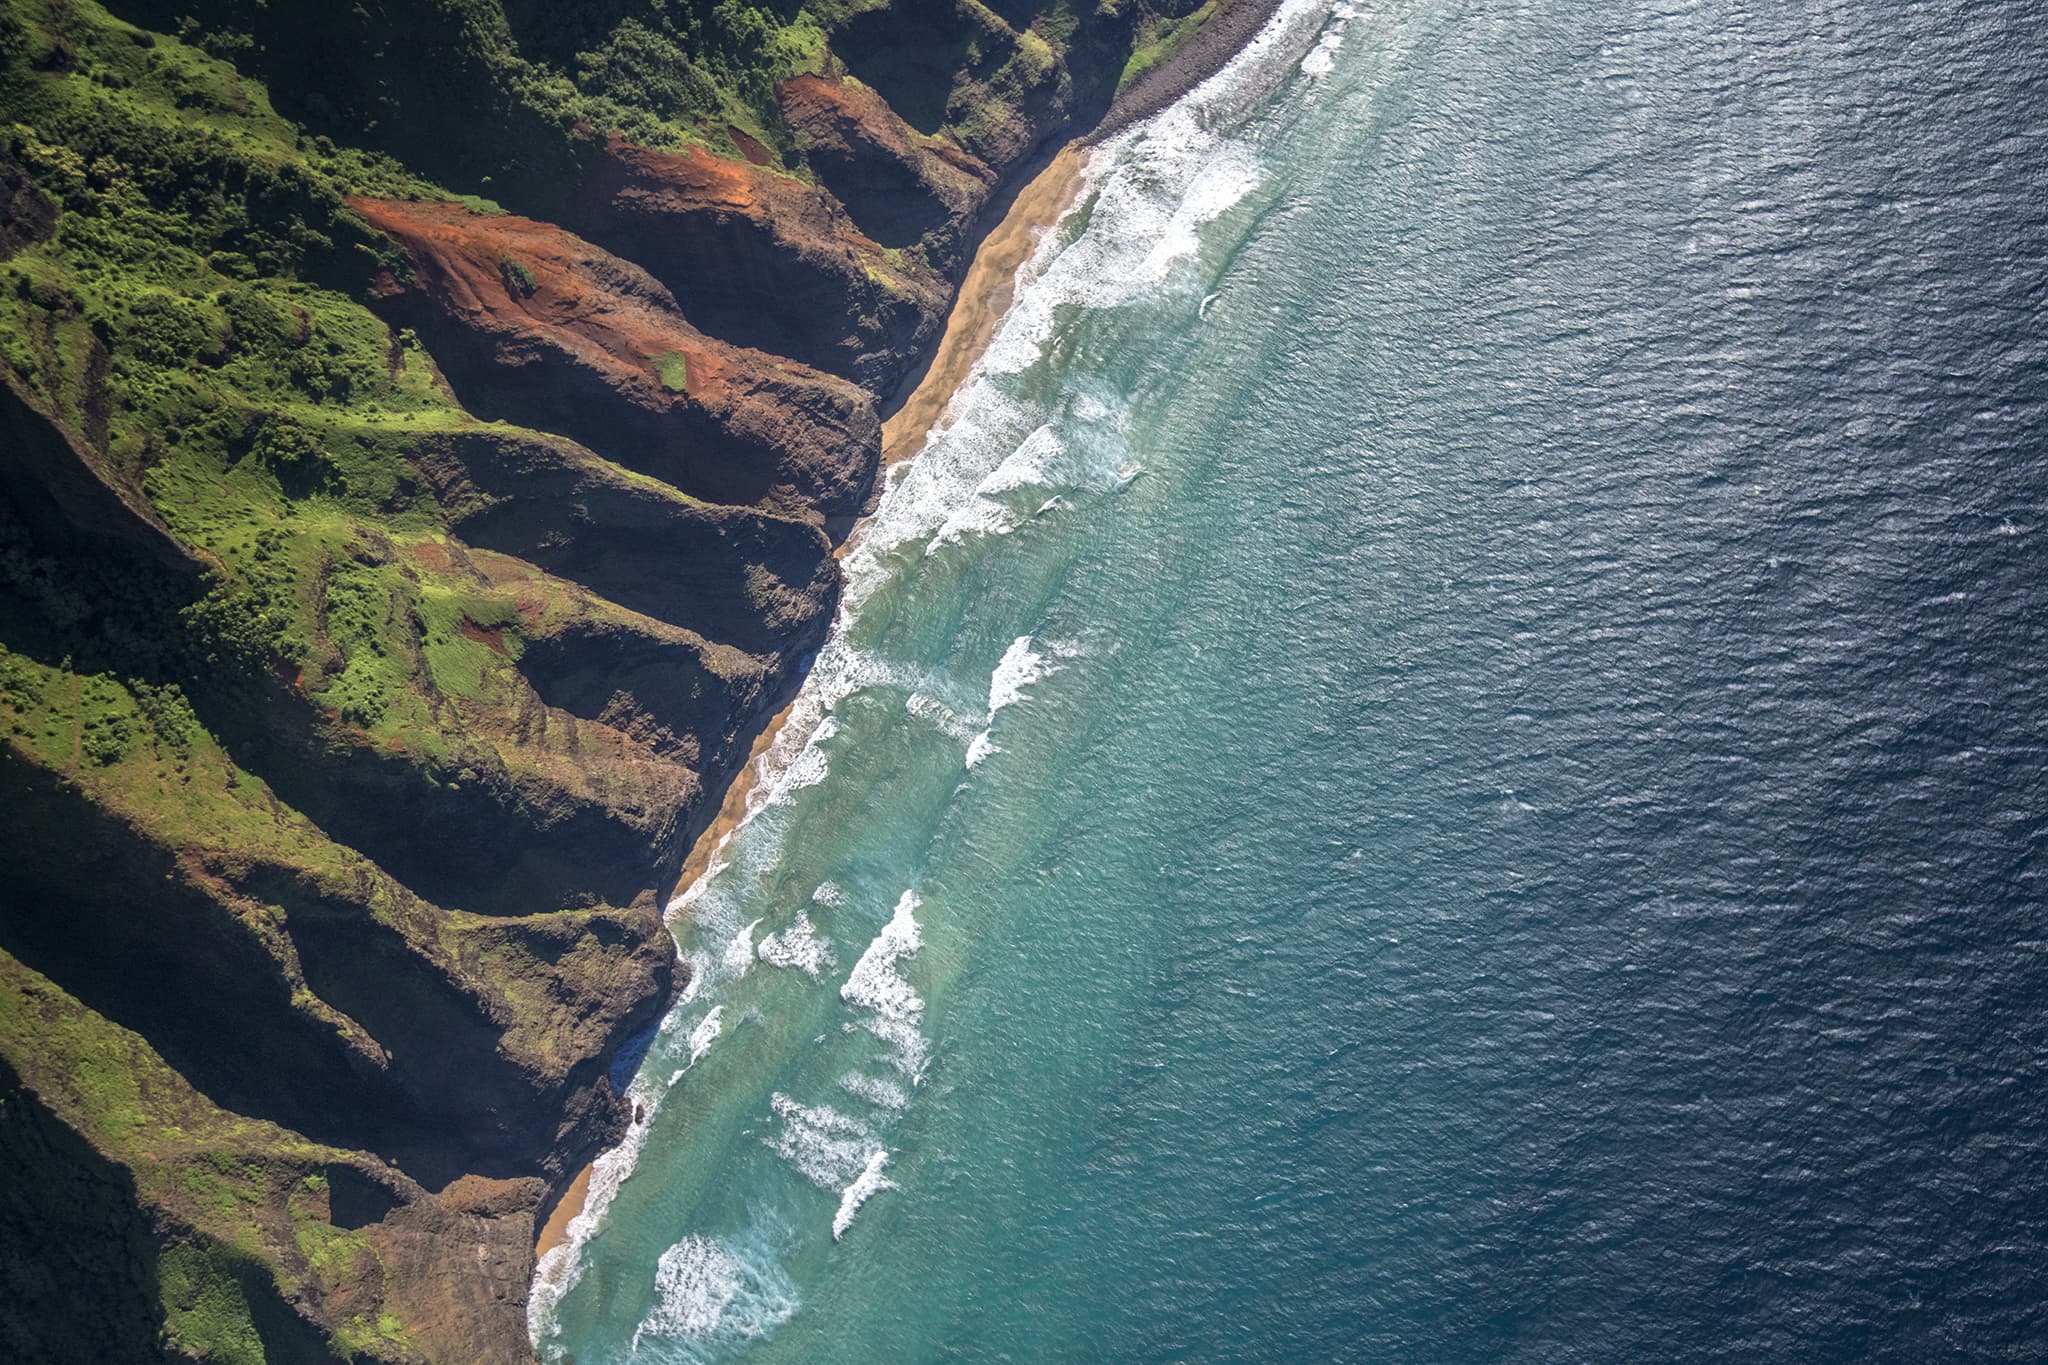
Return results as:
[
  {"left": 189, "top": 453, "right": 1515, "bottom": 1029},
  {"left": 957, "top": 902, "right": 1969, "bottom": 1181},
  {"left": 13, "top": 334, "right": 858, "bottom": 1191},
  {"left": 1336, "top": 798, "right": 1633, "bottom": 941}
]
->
[{"left": 535, "top": 0, "right": 2048, "bottom": 1365}]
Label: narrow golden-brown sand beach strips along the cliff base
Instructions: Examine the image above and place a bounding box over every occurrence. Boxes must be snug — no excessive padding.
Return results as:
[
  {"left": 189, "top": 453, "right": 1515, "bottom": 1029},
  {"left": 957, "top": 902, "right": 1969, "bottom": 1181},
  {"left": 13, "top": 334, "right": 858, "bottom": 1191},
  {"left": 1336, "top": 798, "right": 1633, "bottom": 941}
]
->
[{"left": 535, "top": 0, "right": 1282, "bottom": 1267}]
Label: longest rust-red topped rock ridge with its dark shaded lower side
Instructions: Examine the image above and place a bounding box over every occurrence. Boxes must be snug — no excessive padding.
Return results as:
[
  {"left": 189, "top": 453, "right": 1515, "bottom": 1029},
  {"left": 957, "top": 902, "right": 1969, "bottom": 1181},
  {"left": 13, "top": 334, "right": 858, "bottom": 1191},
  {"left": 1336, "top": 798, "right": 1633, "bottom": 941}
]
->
[{"left": 352, "top": 199, "right": 881, "bottom": 518}]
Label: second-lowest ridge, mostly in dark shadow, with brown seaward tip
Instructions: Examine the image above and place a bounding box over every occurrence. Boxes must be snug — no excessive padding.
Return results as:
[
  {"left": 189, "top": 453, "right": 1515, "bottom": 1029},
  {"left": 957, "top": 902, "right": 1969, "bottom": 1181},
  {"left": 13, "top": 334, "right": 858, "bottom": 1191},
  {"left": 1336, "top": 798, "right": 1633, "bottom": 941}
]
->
[{"left": 0, "top": 755, "right": 674, "bottom": 1187}]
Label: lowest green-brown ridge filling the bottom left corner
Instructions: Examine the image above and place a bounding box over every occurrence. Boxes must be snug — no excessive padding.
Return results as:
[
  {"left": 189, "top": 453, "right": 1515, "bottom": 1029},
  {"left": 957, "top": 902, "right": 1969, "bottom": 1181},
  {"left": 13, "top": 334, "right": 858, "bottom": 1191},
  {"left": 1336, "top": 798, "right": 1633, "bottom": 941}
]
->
[{"left": 0, "top": 952, "right": 577, "bottom": 1365}]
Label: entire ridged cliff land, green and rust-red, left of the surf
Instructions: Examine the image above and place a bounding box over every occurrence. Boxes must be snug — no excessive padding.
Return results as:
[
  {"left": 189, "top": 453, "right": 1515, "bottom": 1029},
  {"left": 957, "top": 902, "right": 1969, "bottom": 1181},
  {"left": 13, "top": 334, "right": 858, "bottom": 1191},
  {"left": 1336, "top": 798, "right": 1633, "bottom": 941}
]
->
[{"left": 0, "top": 0, "right": 1228, "bottom": 1363}]
